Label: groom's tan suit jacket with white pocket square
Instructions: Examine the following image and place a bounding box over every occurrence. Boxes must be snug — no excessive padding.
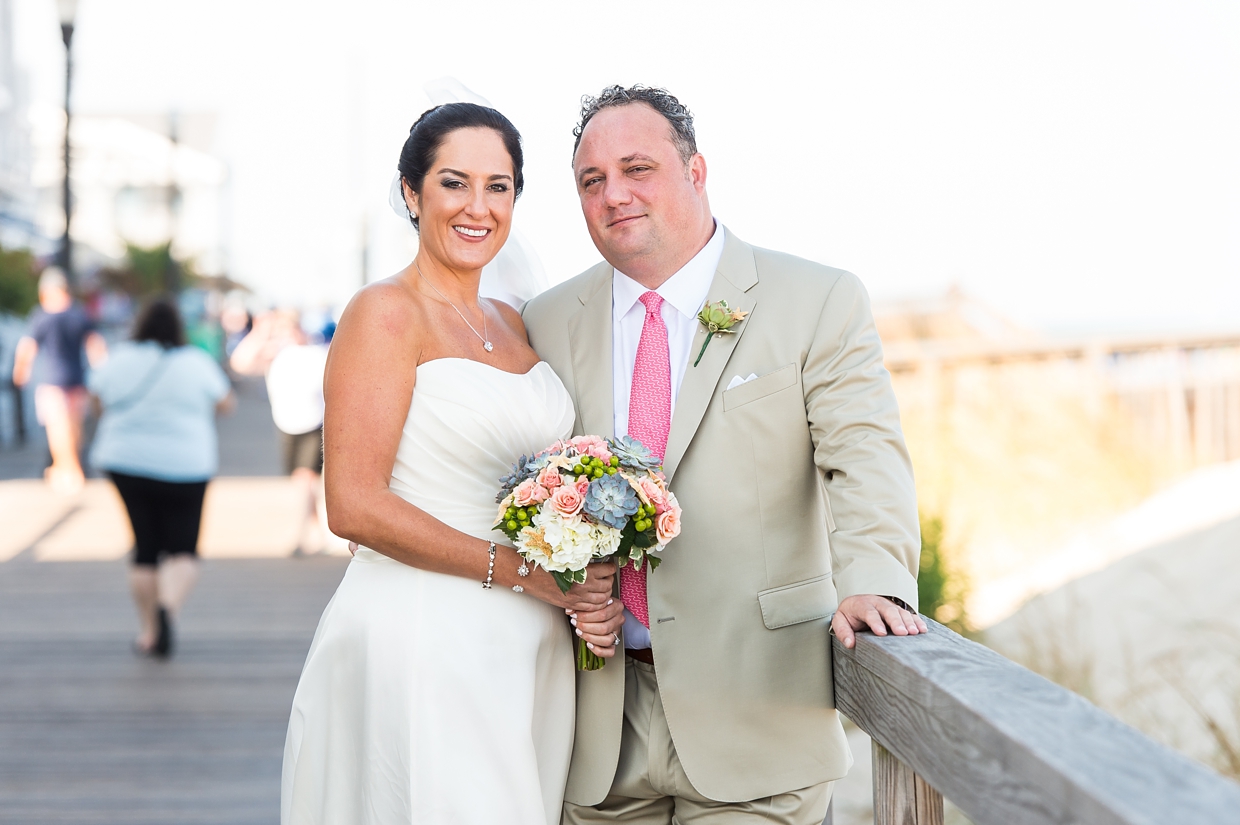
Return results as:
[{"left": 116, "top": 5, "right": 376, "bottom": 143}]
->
[{"left": 523, "top": 232, "right": 920, "bottom": 805}]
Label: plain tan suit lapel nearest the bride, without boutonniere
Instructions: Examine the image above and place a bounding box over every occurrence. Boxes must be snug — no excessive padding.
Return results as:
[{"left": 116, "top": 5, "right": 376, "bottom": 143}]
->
[{"left": 568, "top": 263, "right": 615, "bottom": 437}]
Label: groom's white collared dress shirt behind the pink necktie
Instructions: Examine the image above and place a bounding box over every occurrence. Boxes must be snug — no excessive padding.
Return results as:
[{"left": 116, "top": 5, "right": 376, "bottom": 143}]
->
[{"left": 611, "top": 222, "right": 724, "bottom": 649}]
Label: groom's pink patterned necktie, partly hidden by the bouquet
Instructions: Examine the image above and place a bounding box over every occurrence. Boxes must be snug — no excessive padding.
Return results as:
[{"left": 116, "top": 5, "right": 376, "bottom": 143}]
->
[{"left": 620, "top": 292, "right": 672, "bottom": 628}]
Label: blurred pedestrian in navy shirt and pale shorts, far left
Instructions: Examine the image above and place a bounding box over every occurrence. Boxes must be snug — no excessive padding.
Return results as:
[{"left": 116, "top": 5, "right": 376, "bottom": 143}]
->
[{"left": 12, "top": 267, "right": 108, "bottom": 493}]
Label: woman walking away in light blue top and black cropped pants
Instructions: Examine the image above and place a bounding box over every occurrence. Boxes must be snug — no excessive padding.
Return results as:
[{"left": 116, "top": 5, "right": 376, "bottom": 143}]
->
[{"left": 89, "top": 299, "right": 233, "bottom": 658}]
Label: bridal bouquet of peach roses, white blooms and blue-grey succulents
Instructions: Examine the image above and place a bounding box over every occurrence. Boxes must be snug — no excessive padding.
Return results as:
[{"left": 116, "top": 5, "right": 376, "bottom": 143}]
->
[{"left": 495, "top": 435, "right": 681, "bottom": 670}]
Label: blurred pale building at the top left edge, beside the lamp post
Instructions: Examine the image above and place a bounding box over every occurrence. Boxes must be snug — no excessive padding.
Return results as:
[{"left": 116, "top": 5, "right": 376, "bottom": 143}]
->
[{"left": 0, "top": 0, "right": 37, "bottom": 252}]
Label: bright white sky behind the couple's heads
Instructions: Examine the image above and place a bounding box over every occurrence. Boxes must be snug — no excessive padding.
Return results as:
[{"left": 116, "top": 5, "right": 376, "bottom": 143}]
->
[{"left": 15, "top": 0, "right": 1240, "bottom": 330}]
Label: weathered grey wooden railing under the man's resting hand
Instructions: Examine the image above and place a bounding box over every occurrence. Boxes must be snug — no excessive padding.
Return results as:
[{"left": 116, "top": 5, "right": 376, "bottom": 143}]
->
[{"left": 828, "top": 620, "right": 1240, "bottom": 825}]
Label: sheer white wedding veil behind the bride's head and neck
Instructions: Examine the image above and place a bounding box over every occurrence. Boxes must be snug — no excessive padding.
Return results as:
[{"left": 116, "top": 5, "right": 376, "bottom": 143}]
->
[{"left": 388, "top": 77, "right": 551, "bottom": 309}]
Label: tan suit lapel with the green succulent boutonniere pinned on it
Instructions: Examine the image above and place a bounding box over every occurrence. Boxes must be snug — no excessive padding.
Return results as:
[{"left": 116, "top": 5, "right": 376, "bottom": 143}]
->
[{"left": 664, "top": 227, "right": 758, "bottom": 481}]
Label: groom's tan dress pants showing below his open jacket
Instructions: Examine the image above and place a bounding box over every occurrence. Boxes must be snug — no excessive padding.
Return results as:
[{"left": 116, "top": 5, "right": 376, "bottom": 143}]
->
[{"left": 562, "top": 656, "right": 835, "bottom": 825}]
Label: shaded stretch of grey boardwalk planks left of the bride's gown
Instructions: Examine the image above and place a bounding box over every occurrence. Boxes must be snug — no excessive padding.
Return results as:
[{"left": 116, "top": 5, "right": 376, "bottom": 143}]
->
[{"left": 0, "top": 552, "right": 347, "bottom": 825}]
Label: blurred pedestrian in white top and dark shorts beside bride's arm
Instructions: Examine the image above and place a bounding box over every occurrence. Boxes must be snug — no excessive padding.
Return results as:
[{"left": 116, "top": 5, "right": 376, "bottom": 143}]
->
[{"left": 231, "top": 310, "right": 324, "bottom": 555}]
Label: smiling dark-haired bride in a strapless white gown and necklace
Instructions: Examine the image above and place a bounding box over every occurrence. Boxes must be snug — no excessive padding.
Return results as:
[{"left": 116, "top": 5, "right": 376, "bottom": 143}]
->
[{"left": 280, "top": 103, "right": 622, "bottom": 825}]
